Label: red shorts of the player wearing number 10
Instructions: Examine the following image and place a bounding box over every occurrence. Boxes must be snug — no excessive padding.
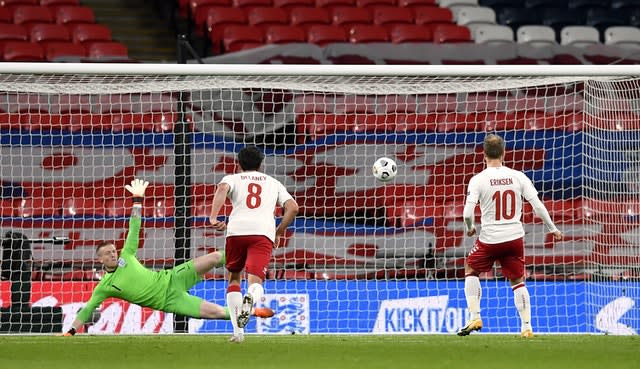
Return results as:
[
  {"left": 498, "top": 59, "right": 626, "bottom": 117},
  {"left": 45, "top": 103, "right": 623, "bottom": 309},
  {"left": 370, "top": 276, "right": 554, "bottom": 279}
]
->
[{"left": 467, "top": 237, "right": 524, "bottom": 280}]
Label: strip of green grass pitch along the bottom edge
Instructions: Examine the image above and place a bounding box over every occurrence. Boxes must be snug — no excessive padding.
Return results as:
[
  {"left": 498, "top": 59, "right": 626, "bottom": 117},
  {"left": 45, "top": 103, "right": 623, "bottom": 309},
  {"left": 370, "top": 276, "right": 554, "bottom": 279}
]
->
[{"left": 0, "top": 334, "right": 640, "bottom": 369}]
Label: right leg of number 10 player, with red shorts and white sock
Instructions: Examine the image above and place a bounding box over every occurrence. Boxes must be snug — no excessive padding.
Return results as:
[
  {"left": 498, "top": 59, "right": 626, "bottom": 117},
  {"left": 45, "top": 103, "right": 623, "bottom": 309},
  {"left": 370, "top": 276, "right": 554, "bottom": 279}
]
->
[{"left": 500, "top": 238, "right": 533, "bottom": 338}]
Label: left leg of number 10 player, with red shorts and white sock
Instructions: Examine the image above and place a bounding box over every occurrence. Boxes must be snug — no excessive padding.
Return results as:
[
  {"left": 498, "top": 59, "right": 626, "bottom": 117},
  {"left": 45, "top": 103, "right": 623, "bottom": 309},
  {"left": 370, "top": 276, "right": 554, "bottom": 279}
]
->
[{"left": 458, "top": 240, "right": 495, "bottom": 336}]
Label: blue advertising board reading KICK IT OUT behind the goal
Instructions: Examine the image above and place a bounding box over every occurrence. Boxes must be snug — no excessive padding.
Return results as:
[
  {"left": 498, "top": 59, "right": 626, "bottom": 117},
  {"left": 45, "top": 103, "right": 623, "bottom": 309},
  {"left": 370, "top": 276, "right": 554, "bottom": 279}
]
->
[{"left": 192, "top": 280, "right": 640, "bottom": 334}]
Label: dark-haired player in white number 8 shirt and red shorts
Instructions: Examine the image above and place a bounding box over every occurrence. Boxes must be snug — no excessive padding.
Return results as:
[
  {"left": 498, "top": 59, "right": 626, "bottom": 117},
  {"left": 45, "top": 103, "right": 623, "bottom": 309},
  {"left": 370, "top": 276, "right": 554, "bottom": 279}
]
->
[{"left": 209, "top": 146, "right": 298, "bottom": 343}]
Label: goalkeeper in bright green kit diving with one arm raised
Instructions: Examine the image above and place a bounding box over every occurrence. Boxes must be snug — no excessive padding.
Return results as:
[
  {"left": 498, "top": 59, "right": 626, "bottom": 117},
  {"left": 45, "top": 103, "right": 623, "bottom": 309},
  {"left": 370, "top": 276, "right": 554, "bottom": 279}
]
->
[{"left": 64, "top": 179, "right": 273, "bottom": 336}]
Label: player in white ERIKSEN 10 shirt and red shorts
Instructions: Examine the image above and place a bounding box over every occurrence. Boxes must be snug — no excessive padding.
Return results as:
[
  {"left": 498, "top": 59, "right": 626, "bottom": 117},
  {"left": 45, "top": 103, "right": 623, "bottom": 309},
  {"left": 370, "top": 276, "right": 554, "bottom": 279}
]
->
[{"left": 458, "top": 134, "right": 562, "bottom": 338}]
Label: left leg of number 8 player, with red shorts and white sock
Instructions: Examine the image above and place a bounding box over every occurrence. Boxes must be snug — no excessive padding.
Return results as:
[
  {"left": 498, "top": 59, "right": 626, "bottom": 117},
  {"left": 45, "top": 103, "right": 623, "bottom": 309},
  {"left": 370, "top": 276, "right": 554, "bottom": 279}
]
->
[{"left": 225, "top": 236, "right": 247, "bottom": 343}]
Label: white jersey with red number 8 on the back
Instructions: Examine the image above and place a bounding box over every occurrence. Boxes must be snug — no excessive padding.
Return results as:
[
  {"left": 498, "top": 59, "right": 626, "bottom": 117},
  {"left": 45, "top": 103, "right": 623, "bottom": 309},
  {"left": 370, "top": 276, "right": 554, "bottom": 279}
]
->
[{"left": 220, "top": 171, "right": 293, "bottom": 241}]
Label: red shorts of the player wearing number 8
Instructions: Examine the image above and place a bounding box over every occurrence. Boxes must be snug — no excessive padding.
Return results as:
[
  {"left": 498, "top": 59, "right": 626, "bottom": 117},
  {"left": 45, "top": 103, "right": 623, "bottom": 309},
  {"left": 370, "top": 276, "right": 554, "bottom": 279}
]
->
[{"left": 224, "top": 235, "right": 273, "bottom": 280}]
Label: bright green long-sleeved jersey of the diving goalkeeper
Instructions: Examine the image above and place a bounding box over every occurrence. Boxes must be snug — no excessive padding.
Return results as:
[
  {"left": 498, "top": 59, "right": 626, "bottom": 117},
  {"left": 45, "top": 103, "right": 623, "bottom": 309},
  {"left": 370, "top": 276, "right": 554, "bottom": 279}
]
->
[{"left": 77, "top": 216, "right": 171, "bottom": 322}]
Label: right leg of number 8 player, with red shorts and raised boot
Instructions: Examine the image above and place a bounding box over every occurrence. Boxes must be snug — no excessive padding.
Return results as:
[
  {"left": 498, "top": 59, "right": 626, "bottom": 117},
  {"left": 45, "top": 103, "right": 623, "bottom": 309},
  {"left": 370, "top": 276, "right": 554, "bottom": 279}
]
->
[{"left": 238, "top": 236, "right": 273, "bottom": 327}]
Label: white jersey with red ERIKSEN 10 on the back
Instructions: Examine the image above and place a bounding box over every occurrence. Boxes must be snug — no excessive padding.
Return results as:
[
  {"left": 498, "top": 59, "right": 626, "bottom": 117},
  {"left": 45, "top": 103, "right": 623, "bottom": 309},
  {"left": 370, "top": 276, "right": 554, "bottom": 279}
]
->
[{"left": 466, "top": 166, "right": 538, "bottom": 244}]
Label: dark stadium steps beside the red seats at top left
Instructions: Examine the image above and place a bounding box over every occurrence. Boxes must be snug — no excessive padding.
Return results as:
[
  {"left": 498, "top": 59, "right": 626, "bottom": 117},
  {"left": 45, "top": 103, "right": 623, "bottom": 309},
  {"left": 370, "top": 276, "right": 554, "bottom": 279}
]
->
[{"left": 82, "top": 0, "right": 176, "bottom": 63}]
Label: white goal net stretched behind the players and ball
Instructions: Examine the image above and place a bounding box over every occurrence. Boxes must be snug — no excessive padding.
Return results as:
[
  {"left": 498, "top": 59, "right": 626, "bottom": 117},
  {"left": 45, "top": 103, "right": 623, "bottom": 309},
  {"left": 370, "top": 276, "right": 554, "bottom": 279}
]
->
[{"left": 0, "top": 65, "right": 640, "bottom": 334}]
